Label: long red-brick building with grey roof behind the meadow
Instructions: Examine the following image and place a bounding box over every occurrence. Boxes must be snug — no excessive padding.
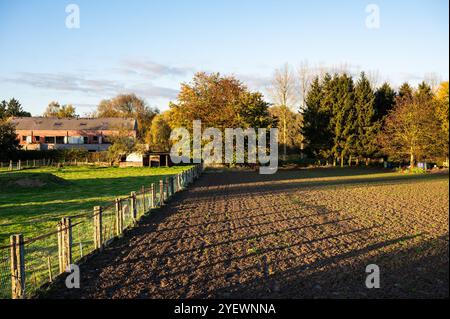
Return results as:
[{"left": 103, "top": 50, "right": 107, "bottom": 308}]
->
[{"left": 10, "top": 117, "right": 137, "bottom": 152}]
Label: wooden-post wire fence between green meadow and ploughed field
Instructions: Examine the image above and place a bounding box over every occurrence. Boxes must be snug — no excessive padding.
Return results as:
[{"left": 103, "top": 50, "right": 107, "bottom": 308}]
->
[{"left": 0, "top": 164, "right": 203, "bottom": 299}]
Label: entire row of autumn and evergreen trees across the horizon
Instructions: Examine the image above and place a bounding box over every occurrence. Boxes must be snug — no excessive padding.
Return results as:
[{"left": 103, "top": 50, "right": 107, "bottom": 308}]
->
[{"left": 0, "top": 65, "right": 449, "bottom": 166}]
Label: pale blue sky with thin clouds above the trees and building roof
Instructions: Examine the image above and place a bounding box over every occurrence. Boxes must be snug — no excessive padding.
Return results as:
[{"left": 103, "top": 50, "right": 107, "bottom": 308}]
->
[{"left": 0, "top": 0, "right": 449, "bottom": 115}]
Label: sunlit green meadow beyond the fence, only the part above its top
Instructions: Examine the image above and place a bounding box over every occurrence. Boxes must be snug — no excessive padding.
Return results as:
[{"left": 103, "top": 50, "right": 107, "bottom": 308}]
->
[{"left": 0, "top": 166, "right": 190, "bottom": 245}]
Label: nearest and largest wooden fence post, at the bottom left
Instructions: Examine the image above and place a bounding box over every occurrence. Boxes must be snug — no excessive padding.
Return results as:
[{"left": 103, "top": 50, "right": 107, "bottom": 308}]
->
[{"left": 11, "top": 234, "right": 25, "bottom": 299}]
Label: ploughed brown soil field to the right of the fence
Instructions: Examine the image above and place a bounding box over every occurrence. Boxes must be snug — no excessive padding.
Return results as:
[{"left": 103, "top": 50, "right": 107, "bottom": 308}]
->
[{"left": 41, "top": 170, "right": 449, "bottom": 298}]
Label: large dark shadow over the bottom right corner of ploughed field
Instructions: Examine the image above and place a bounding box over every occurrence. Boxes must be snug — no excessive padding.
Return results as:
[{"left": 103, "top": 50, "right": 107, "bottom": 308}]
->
[{"left": 208, "top": 236, "right": 449, "bottom": 299}]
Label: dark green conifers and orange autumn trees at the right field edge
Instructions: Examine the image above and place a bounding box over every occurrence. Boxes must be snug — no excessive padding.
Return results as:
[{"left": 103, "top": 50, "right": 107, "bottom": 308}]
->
[{"left": 302, "top": 73, "right": 448, "bottom": 167}]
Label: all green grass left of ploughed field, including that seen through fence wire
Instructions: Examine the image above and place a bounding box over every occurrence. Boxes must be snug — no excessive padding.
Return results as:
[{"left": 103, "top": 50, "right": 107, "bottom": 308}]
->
[{"left": 0, "top": 166, "right": 190, "bottom": 299}]
